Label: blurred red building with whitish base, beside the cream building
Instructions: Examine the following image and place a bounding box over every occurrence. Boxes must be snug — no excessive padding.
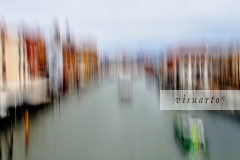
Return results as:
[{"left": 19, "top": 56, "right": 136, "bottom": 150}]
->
[{"left": 23, "top": 28, "right": 49, "bottom": 105}]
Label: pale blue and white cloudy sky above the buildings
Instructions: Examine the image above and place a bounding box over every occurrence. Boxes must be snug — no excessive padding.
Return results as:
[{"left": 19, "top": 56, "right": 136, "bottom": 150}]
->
[{"left": 0, "top": 0, "right": 240, "bottom": 50}]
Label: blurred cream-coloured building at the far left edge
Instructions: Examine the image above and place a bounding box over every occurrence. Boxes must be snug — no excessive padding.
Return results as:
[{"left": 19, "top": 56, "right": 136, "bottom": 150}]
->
[{"left": 0, "top": 23, "right": 27, "bottom": 117}]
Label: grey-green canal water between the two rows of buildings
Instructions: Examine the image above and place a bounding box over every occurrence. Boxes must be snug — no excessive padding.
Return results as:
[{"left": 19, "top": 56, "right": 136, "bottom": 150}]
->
[{"left": 0, "top": 74, "right": 240, "bottom": 160}]
